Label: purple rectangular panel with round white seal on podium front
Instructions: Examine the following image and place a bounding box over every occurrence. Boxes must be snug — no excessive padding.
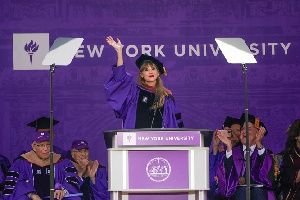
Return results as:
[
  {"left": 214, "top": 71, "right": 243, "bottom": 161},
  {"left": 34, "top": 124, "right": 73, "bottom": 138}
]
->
[{"left": 128, "top": 151, "right": 189, "bottom": 189}]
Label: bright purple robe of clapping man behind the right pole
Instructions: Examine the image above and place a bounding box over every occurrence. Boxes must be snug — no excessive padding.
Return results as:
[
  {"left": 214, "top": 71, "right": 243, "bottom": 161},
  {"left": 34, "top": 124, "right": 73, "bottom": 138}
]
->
[{"left": 217, "top": 146, "right": 275, "bottom": 200}]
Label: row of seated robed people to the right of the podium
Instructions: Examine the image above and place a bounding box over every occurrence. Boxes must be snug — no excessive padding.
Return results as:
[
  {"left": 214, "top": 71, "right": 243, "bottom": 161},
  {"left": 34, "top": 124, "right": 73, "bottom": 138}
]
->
[{"left": 207, "top": 114, "right": 300, "bottom": 200}]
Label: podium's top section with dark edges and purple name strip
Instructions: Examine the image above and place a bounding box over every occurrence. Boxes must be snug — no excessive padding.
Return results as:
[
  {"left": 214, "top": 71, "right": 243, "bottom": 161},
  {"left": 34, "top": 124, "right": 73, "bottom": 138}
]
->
[{"left": 104, "top": 128, "right": 213, "bottom": 148}]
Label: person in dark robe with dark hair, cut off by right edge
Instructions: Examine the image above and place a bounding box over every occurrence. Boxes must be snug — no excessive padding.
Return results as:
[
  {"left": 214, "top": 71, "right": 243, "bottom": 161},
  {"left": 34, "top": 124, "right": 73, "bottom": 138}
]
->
[{"left": 281, "top": 119, "right": 300, "bottom": 200}]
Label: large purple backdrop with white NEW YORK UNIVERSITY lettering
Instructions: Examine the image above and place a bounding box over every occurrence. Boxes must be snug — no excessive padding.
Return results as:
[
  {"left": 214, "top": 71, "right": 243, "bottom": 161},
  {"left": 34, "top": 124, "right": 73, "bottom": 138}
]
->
[{"left": 0, "top": 0, "right": 300, "bottom": 165}]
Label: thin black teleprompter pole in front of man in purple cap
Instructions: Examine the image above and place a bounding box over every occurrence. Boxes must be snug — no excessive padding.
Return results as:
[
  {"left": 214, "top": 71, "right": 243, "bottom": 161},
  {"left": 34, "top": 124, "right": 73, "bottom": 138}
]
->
[{"left": 50, "top": 64, "right": 56, "bottom": 200}]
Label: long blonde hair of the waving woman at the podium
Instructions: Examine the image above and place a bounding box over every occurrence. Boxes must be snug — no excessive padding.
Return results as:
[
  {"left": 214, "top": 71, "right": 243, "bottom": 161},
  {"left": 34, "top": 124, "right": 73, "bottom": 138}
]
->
[{"left": 137, "top": 61, "right": 168, "bottom": 109}]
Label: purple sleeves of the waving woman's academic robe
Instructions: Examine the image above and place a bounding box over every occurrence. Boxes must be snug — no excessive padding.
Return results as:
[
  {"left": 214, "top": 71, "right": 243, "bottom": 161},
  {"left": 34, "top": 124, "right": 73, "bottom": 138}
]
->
[{"left": 104, "top": 65, "right": 183, "bottom": 129}]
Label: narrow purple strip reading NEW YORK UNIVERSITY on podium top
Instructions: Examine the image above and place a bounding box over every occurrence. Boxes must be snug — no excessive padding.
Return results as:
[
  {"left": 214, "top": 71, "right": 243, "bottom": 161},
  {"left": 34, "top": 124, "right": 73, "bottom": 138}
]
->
[{"left": 118, "top": 131, "right": 200, "bottom": 146}]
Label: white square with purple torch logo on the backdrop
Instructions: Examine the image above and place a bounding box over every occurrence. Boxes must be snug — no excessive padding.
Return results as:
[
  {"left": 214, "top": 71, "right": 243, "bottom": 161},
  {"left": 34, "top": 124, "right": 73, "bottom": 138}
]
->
[{"left": 13, "top": 33, "right": 50, "bottom": 70}]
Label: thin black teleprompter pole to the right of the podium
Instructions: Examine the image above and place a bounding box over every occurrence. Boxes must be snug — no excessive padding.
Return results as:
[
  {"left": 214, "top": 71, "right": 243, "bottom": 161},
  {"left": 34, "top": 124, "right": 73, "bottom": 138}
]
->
[{"left": 242, "top": 64, "right": 251, "bottom": 200}]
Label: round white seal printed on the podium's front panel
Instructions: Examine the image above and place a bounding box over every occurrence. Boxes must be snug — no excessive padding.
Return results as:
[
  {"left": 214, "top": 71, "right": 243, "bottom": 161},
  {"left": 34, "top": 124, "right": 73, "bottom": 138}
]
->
[{"left": 146, "top": 157, "right": 171, "bottom": 182}]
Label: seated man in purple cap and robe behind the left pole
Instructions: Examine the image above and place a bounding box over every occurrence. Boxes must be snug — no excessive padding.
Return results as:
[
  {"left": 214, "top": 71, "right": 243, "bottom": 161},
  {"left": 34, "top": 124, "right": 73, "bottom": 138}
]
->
[{"left": 4, "top": 132, "right": 82, "bottom": 200}]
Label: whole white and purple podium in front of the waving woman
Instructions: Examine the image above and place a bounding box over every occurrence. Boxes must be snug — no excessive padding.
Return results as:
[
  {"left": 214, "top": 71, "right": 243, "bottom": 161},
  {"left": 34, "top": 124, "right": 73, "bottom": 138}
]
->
[{"left": 104, "top": 129, "right": 213, "bottom": 200}]
